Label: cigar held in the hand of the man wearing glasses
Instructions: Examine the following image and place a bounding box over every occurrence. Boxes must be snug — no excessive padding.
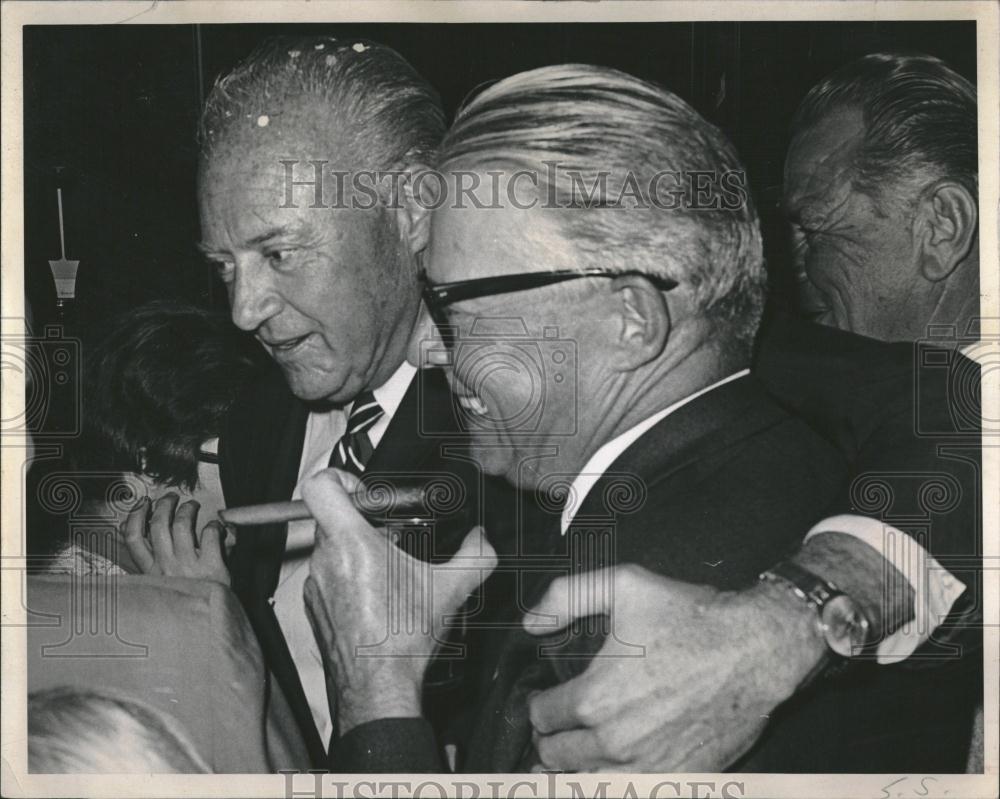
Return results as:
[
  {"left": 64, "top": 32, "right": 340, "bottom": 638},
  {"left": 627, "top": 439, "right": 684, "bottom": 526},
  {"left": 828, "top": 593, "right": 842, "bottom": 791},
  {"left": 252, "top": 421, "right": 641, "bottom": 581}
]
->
[{"left": 219, "top": 485, "right": 432, "bottom": 527}]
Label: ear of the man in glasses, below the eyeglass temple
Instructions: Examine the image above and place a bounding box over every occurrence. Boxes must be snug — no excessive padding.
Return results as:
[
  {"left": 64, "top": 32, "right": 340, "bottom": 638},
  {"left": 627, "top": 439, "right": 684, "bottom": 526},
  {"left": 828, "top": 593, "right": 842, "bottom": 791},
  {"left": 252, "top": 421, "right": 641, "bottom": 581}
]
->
[{"left": 611, "top": 275, "right": 671, "bottom": 371}]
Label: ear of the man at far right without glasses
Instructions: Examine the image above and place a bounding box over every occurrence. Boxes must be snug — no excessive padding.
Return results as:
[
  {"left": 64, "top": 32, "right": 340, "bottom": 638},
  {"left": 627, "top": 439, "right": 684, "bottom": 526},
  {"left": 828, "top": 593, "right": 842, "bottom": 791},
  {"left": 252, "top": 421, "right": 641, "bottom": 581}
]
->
[{"left": 916, "top": 180, "right": 979, "bottom": 283}]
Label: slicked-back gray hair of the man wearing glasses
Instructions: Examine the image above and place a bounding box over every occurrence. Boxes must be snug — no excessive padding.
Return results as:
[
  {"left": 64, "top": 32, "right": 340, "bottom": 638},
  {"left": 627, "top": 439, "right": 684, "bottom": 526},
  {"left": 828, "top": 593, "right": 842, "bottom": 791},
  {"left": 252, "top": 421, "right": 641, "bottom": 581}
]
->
[{"left": 438, "top": 64, "right": 766, "bottom": 345}]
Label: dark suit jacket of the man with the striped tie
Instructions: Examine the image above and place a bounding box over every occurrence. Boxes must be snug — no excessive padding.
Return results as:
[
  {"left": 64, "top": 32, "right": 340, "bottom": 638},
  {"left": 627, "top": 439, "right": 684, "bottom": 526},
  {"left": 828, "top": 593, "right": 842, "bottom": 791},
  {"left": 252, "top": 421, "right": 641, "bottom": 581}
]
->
[{"left": 219, "top": 367, "right": 532, "bottom": 768}]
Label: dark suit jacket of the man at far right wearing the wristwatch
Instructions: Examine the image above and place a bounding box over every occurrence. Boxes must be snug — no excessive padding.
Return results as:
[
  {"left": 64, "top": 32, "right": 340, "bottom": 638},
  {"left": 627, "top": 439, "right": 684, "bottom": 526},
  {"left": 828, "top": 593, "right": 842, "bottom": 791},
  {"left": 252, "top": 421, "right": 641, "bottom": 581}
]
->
[{"left": 744, "top": 314, "right": 983, "bottom": 773}]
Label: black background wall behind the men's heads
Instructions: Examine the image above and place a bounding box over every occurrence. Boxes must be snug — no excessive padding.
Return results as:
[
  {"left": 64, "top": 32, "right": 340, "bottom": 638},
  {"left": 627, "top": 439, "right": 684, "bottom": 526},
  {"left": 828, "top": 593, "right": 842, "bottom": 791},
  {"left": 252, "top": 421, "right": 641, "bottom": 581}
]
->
[{"left": 24, "top": 22, "right": 976, "bottom": 354}]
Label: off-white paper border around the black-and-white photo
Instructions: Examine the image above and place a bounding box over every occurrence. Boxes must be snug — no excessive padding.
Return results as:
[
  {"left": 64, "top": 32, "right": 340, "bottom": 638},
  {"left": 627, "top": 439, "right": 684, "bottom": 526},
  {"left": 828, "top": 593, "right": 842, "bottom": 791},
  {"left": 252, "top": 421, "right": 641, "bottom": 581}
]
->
[{"left": 0, "top": 0, "right": 1000, "bottom": 799}]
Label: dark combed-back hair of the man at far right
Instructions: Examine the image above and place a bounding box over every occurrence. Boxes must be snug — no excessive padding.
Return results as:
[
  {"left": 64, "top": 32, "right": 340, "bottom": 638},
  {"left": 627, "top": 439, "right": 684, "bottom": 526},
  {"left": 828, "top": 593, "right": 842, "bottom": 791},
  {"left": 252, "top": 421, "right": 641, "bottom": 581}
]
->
[{"left": 792, "top": 53, "right": 979, "bottom": 206}]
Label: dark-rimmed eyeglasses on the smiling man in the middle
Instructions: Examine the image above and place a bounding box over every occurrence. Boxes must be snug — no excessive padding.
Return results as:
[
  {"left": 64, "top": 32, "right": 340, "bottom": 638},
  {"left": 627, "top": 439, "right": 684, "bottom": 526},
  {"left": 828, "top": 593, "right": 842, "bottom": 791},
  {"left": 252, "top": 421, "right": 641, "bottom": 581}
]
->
[{"left": 420, "top": 267, "right": 678, "bottom": 348}]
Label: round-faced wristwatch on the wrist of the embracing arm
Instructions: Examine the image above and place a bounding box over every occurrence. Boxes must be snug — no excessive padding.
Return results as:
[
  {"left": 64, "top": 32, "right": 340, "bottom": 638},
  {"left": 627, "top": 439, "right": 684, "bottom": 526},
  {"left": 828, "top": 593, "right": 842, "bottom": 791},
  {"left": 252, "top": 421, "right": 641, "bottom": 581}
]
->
[{"left": 760, "top": 561, "right": 871, "bottom": 658}]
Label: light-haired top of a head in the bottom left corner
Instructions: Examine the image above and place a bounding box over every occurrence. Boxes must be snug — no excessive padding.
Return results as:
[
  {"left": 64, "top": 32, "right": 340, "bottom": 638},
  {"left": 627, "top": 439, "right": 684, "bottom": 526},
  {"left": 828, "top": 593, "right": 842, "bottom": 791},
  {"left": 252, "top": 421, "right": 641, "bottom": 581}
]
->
[{"left": 28, "top": 686, "right": 212, "bottom": 774}]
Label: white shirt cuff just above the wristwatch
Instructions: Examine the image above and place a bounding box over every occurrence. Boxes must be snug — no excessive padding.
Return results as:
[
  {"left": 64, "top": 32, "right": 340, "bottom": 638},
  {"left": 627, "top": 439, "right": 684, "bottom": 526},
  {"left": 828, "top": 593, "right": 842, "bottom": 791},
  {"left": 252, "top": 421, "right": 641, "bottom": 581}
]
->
[{"left": 805, "top": 514, "right": 965, "bottom": 665}]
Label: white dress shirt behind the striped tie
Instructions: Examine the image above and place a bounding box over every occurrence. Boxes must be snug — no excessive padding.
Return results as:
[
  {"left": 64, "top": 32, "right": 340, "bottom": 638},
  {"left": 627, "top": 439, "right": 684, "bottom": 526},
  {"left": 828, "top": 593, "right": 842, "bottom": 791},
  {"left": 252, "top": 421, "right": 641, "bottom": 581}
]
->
[{"left": 271, "top": 361, "right": 417, "bottom": 744}]
